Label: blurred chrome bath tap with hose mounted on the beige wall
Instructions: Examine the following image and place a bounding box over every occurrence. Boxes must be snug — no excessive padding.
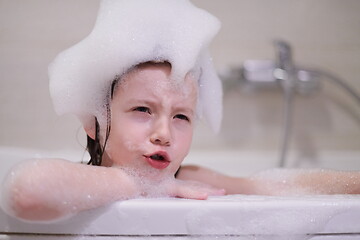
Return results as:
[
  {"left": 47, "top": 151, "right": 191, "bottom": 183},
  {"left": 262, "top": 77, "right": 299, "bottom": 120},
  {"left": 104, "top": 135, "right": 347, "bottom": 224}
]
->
[{"left": 220, "top": 40, "right": 360, "bottom": 167}]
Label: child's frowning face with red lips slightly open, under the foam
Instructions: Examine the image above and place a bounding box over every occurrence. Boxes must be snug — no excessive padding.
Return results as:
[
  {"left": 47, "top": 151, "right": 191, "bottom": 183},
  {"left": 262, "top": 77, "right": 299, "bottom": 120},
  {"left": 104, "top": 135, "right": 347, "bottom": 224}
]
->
[{"left": 106, "top": 64, "right": 197, "bottom": 178}]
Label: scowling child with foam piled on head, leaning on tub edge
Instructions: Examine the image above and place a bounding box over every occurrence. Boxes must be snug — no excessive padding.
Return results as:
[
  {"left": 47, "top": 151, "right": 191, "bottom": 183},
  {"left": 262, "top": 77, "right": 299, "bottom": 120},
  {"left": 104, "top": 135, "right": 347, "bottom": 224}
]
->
[{"left": 1, "top": 0, "right": 360, "bottom": 221}]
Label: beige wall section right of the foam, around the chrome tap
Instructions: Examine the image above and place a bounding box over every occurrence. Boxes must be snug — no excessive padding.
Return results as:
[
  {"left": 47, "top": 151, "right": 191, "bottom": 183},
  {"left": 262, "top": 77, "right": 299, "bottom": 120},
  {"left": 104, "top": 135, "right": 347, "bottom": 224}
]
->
[{"left": 190, "top": 0, "right": 360, "bottom": 157}]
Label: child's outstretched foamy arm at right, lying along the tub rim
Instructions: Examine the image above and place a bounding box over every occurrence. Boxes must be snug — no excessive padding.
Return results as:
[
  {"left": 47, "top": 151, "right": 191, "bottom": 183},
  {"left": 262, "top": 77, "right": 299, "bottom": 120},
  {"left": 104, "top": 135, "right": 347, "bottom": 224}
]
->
[{"left": 178, "top": 166, "right": 360, "bottom": 195}]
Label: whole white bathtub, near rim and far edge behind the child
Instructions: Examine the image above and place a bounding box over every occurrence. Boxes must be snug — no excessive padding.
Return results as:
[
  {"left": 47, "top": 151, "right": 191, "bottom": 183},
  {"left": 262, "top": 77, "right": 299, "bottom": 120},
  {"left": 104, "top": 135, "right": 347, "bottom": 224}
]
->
[{"left": 0, "top": 148, "right": 360, "bottom": 240}]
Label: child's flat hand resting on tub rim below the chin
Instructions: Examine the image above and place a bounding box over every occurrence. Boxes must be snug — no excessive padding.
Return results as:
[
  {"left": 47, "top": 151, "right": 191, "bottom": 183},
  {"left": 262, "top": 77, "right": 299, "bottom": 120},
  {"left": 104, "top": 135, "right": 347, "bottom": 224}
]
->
[{"left": 165, "top": 179, "right": 225, "bottom": 200}]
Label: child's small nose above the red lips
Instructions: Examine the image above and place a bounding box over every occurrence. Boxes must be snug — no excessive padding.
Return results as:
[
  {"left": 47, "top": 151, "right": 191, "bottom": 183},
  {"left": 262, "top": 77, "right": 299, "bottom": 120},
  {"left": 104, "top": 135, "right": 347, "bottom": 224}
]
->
[{"left": 150, "top": 119, "right": 171, "bottom": 146}]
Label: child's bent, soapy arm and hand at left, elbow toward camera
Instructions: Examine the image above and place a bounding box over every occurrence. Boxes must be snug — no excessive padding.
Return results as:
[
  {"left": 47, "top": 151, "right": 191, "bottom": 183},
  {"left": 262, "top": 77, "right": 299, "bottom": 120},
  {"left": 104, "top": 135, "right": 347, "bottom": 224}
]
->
[{"left": 1, "top": 159, "right": 224, "bottom": 221}]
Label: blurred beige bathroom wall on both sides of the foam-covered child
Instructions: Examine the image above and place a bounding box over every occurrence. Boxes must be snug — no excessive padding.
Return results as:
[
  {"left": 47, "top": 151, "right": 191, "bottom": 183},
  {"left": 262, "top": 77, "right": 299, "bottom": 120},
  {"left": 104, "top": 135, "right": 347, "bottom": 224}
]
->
[{"left": 0, "top": 0, "right": 360, "bottom": 155}]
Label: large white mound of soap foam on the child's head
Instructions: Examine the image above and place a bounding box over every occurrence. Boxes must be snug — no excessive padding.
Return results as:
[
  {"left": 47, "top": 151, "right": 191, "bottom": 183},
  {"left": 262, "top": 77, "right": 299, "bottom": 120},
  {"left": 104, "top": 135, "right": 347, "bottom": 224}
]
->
[{"left": 49, "top": 0, "right": 222, "bottom": 131}]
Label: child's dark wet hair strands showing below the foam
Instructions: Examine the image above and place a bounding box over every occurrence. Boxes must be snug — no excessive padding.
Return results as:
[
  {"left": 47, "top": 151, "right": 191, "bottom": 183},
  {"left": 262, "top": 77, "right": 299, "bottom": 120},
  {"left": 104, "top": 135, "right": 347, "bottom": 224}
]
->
[{"left": 86, "top": 61, "right": 171, "bottom": 166}]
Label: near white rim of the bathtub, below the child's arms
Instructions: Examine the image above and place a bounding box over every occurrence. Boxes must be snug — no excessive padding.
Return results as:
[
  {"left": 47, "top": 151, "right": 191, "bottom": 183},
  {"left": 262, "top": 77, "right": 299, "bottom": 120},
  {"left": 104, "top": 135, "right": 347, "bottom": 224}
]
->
[{"left": 0, "top": 195, "right": 360, "bottom": 239}]
